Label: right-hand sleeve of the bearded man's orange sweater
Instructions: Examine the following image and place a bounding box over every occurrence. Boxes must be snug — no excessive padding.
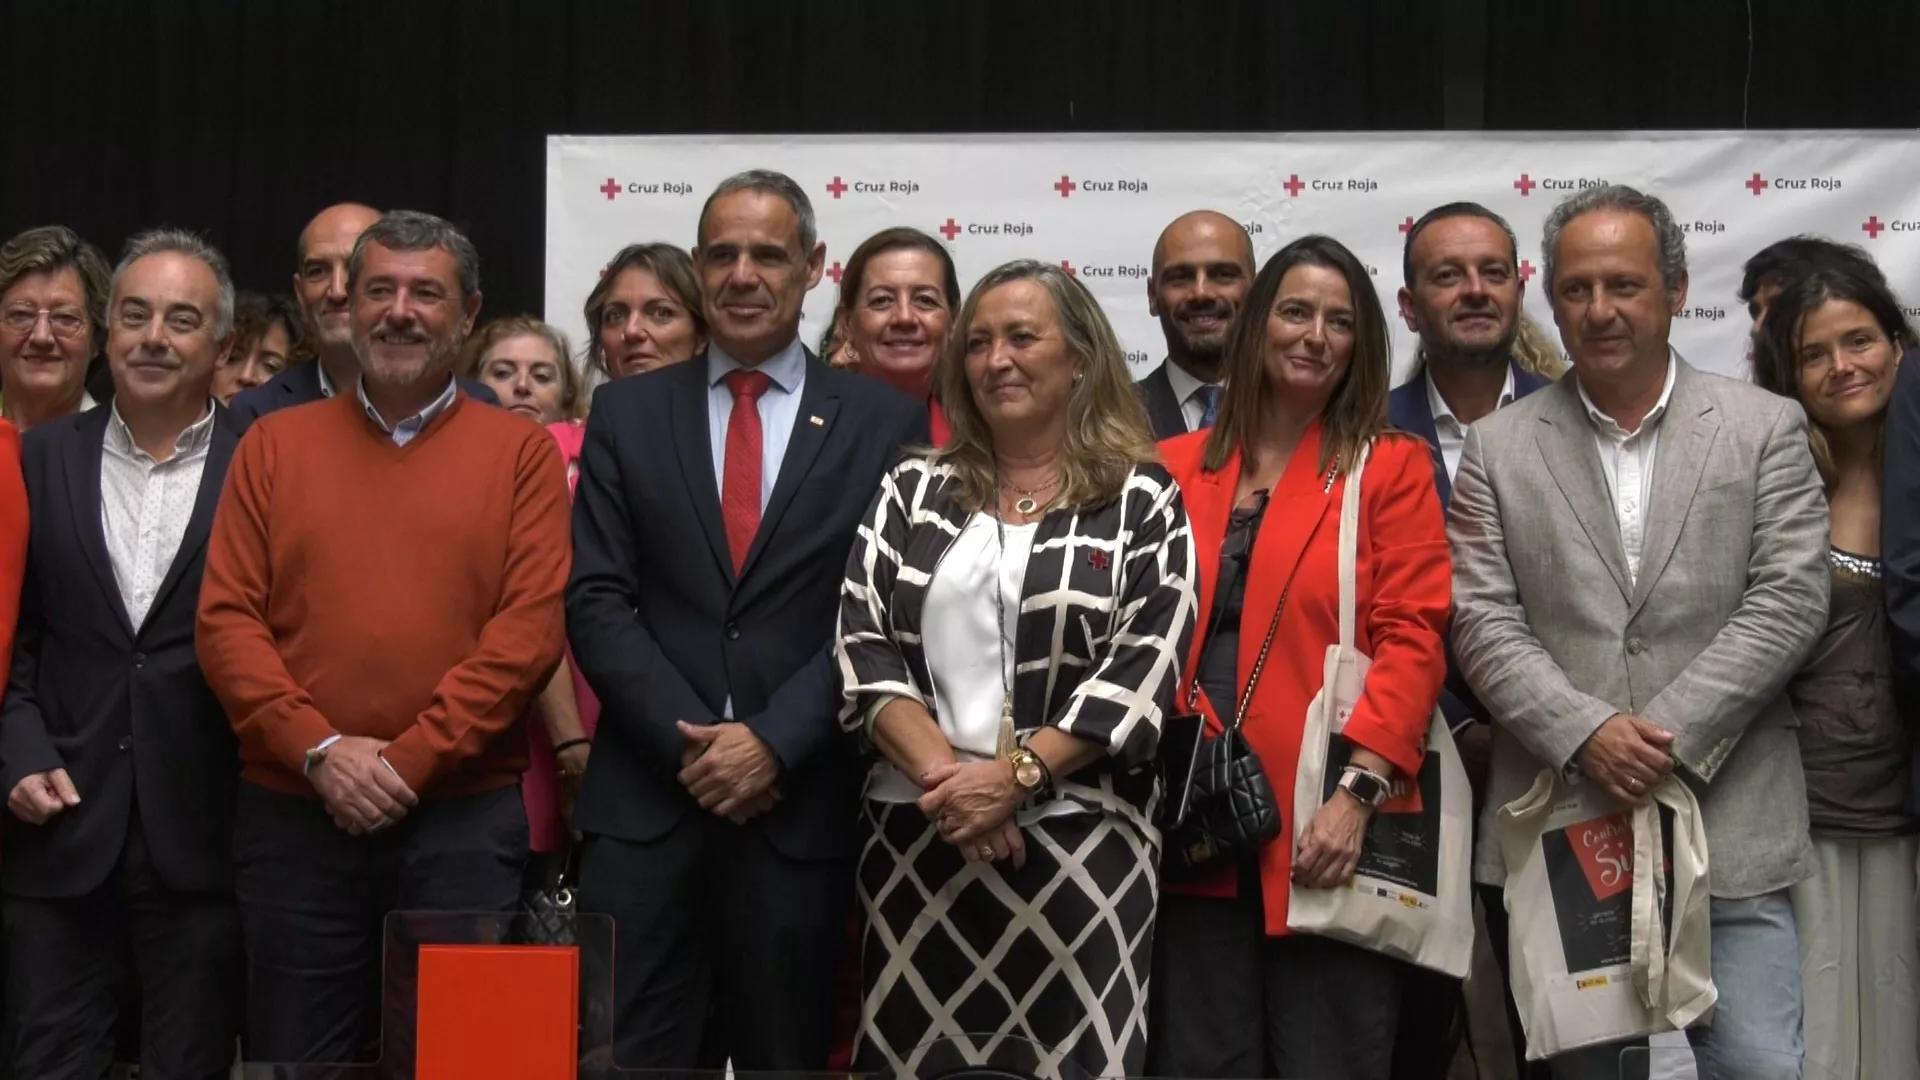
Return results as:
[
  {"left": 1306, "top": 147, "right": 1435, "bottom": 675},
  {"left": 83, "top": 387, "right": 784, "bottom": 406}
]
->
[{"left": 384, "top": 427, "right": 572, "bottom": 792}]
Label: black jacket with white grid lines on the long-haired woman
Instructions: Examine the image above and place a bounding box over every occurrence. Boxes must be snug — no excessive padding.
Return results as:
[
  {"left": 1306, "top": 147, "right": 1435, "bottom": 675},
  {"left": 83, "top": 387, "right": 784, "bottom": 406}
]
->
[{"left": 833, "top": 449, "right": 1198, "bottom": 818}]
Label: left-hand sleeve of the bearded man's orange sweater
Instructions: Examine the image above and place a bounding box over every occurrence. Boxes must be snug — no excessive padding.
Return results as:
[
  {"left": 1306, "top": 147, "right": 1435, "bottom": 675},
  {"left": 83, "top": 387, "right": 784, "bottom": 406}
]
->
[{"left": 194, "top": 425, "right": 338, "bottom": 776}]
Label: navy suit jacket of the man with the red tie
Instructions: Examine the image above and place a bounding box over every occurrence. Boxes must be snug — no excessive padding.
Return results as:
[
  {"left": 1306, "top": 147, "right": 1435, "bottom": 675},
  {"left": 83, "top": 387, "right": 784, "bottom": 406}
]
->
[{"left": 566, "top": 354, "right": 929, "bottom": 859}]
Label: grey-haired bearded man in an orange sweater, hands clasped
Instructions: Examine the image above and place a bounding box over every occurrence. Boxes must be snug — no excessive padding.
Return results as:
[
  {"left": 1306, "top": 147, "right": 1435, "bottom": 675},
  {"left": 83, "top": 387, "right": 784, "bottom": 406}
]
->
[{"left": 200, "top": 211, "right": 568, "bottom": 1076}]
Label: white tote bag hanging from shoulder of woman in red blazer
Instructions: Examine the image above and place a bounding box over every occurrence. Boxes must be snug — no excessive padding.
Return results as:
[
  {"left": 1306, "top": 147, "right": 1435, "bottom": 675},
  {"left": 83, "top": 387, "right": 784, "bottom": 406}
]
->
[{"left": 1286, "top": 438, "right": 1473, "bottom": 978}]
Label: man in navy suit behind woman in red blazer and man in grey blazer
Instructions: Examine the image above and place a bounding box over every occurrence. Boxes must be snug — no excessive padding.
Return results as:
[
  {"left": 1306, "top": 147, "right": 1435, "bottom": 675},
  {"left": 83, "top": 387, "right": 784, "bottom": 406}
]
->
[{"left": 1386, "top": 202, "right": 1549, "bottom": 1080}]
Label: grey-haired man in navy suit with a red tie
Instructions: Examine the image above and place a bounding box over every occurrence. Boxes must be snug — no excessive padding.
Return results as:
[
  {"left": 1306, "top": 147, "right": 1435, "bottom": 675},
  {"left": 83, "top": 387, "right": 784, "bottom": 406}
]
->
[{"left": 566, "top": 171, "right": 929, "bottom": 1072}]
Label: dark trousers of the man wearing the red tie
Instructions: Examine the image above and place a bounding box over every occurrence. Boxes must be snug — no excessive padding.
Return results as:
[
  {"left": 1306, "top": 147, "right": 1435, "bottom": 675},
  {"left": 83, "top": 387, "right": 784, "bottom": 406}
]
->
[{"left": 580, "top": 811, "right": 854, "bottom": 1072}]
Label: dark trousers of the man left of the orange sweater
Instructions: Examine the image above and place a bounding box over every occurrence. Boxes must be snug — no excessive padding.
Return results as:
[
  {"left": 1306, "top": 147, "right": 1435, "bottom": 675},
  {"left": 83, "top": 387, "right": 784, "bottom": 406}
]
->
[{"left": 4, "top": 817, "right": 244, "bottom": 1080}]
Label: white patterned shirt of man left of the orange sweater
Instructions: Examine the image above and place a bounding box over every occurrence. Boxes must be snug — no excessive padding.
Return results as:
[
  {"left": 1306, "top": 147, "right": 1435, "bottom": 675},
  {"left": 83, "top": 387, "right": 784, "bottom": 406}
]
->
[{"left": 100, "top": 402, "right": 213, "bottom": 630}]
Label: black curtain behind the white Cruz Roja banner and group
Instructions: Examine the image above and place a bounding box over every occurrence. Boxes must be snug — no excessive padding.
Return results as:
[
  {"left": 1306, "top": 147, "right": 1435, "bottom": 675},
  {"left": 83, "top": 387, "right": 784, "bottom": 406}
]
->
[{"left": 0, "top": 0, "right": 1920, "bottom": 315}]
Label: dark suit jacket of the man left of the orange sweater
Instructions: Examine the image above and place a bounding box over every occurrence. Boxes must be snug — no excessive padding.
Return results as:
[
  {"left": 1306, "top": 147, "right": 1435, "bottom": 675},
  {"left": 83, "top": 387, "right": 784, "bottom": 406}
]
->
[{"left": 0, "top": 405, "right": 240, "bottom": 897}]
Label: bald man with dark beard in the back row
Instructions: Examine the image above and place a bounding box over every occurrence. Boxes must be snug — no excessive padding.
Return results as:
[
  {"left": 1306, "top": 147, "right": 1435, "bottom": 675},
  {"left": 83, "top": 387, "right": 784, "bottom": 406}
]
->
[{"left": 1135, "top": 209, "right": 1254, "bottom": 438}]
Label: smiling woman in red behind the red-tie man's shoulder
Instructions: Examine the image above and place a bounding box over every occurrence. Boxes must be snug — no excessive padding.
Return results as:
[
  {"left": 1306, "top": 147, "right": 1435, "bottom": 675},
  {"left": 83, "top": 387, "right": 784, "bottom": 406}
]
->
[{"left": 828, "top": 227, "right": 960, "bottom": 446}]
